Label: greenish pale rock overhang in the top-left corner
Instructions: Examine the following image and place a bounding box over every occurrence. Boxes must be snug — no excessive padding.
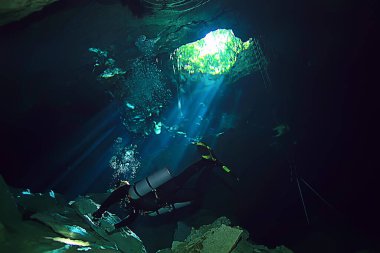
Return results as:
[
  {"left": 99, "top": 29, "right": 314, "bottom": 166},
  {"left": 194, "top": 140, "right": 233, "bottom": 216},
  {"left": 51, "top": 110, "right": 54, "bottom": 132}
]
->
[{"left": 0, "top": 0, "right": 57, "bottom": 26}]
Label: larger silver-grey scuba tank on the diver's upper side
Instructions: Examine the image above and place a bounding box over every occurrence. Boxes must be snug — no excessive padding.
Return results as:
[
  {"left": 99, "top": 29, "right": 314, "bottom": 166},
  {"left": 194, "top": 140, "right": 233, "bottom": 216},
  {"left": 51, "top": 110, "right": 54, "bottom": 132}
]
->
[{"left": 128, "top": 168, "right": 172, "bottom": 200}]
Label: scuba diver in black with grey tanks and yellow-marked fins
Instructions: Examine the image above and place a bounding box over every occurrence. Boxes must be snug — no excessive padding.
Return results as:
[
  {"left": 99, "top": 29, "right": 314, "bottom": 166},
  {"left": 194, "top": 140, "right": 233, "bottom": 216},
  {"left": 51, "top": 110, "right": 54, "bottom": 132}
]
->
[{"left": 92, "top": 142, "right": 239, "bottom": 232}]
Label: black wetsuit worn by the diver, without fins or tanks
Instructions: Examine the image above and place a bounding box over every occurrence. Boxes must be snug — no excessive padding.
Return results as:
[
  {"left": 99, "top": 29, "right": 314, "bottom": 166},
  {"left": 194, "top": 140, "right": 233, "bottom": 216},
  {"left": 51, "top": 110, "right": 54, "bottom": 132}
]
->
[{"left": 93, "top": 159, "right": 222, "bottom": 229}]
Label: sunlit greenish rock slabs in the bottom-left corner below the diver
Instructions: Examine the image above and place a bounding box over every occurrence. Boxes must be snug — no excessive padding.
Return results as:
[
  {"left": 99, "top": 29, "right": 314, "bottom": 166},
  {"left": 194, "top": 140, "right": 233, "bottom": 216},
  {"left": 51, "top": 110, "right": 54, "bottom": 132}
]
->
[{"left": 0, "top": 176, "right": 146, "bottom": 253}]
